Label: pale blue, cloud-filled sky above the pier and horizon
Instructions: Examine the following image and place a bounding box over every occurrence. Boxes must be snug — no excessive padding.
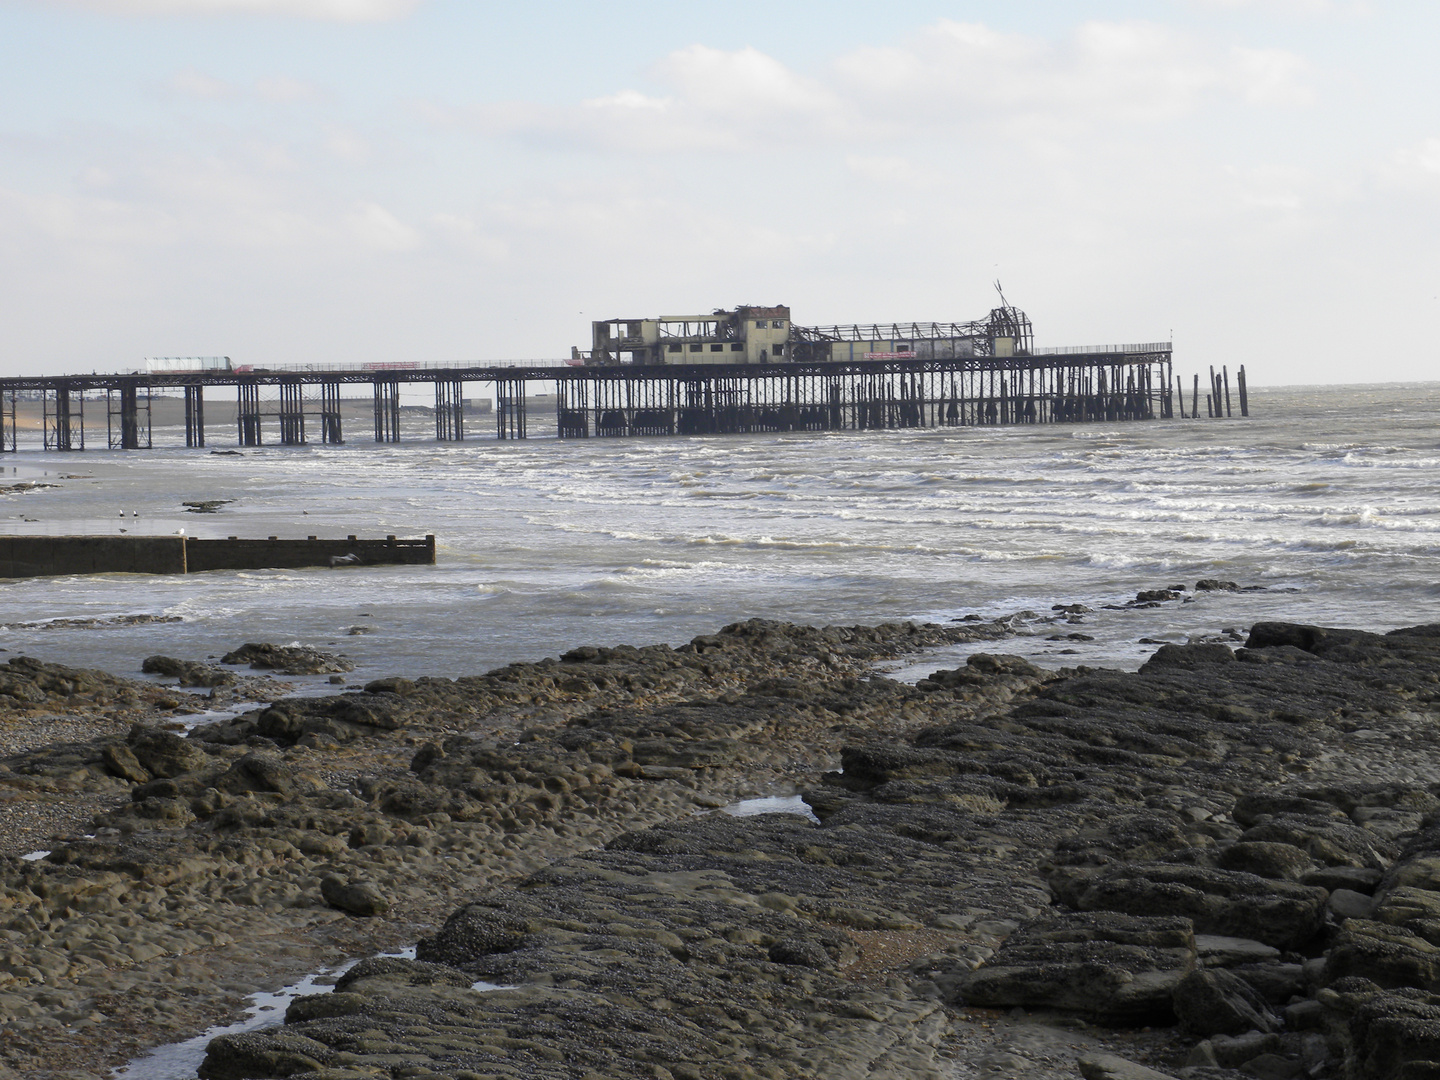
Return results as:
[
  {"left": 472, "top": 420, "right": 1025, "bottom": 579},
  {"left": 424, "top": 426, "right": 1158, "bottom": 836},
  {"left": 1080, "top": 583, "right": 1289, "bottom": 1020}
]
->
[{"left": 0, "top": 0, "right": 1440, "bottom": 384}]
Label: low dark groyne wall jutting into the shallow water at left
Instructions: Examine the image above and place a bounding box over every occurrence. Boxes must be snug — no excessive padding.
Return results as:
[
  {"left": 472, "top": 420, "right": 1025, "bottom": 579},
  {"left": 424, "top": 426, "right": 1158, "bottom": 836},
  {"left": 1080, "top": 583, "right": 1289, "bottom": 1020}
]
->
[{"left": 0, "top": 536, "right": 435, "bottom": 577}]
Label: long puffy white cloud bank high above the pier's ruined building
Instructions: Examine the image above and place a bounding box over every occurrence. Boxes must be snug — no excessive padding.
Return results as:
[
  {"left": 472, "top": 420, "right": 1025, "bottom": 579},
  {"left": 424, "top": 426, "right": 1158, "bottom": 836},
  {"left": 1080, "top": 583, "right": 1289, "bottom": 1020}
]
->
[{"left": 429, "top": 19, "right": 1310, "bottom": 157}]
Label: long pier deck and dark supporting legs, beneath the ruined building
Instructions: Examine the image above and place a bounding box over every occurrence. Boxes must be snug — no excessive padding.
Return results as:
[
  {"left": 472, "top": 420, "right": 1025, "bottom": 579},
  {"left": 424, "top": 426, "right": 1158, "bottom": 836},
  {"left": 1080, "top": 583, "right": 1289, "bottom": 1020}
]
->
[{"left": 0, "top": 341, "right": 1248, "bottom": 451}]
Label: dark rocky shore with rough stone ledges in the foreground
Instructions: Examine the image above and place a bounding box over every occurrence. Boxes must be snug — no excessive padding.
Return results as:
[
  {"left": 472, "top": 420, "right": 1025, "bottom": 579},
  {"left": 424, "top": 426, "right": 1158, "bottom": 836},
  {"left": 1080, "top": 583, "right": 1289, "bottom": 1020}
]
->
[{"left": 0, "top": 621, "right": 1440, "bottom": 1080}]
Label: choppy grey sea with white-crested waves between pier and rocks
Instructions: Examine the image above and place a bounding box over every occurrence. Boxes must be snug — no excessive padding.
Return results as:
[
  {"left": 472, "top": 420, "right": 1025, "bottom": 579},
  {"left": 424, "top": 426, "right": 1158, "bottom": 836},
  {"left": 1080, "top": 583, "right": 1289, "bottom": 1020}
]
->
[{"left": 0, "top": 383, "right": 1440, "bottom": 678}]
